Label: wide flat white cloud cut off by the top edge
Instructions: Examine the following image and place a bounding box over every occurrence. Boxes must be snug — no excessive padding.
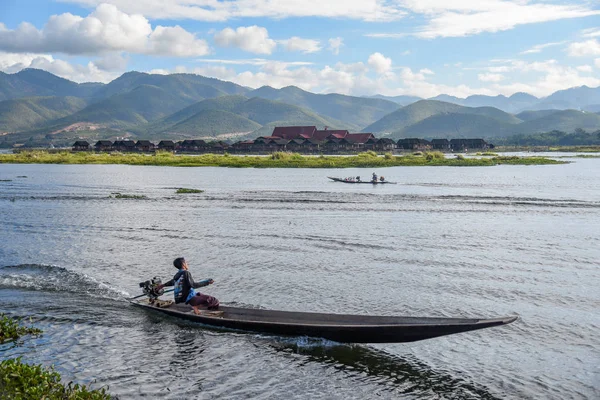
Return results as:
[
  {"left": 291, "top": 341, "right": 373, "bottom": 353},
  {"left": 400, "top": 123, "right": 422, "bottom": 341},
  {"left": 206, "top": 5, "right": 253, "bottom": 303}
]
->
[{"left": 63, "top": 0, "right": 406, "bottom": 22}]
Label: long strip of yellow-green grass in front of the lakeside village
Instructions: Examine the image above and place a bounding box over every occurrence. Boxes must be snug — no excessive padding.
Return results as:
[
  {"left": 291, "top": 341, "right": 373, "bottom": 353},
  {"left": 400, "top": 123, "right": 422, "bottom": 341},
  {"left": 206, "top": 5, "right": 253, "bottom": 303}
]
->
[{"left": 0, "top": 151, "right": 567, "bottom": 168}]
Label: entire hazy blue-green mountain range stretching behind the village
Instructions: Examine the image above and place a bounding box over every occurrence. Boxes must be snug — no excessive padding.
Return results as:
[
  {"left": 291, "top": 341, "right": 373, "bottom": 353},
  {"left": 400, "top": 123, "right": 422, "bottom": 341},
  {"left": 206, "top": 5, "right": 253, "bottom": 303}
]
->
[{"left": 0, "top": 69, "right": 600, "bottom": 147}]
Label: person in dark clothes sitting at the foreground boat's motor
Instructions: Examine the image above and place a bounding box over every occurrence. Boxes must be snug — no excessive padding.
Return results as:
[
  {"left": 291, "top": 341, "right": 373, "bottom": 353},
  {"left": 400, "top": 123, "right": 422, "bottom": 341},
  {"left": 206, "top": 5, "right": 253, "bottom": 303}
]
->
[{"left": 162, "top": 257, "right": 219, "bottom": 314}]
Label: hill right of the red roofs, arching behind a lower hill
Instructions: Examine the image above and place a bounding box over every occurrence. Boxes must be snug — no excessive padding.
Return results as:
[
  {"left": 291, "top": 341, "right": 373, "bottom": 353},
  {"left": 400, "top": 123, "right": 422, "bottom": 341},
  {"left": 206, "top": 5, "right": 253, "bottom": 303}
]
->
[{"left": 363, "top": 100, "right": 521, "bottom": 136}]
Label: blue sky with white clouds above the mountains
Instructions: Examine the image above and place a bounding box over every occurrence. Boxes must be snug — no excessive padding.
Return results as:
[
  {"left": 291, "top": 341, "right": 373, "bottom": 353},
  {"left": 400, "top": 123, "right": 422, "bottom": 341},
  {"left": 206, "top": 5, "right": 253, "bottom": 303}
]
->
[{"left": 0, "top": 0, "right": 600, "bottom": 98}]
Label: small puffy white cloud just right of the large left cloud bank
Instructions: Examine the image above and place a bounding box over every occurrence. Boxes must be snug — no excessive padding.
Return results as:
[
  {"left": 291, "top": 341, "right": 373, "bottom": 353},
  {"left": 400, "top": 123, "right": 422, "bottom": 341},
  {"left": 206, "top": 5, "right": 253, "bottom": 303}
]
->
[{"left": 215, "top": 25, "right": 277, "bottom": 54}]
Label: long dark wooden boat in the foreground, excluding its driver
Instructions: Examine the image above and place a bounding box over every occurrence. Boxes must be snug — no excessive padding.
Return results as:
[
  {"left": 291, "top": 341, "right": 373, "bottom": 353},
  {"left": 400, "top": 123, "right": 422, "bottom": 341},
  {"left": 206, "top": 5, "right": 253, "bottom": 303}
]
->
[{"left": 131, "top": 299, "right": 518, "bottom": 343}]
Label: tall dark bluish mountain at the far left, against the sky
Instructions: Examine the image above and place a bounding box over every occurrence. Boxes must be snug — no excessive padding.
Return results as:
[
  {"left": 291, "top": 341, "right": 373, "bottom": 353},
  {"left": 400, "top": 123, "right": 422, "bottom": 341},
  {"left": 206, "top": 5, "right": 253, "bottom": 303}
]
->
[{"left": 0, "top": 68, "right": 104, "bottom": 101}]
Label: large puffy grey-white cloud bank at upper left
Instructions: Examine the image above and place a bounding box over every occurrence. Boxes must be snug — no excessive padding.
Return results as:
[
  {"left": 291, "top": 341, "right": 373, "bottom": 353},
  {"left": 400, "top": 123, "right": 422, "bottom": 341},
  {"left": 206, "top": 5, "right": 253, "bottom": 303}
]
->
[{"left": 0, "top": 4, "right": 209, "bottom": 57}]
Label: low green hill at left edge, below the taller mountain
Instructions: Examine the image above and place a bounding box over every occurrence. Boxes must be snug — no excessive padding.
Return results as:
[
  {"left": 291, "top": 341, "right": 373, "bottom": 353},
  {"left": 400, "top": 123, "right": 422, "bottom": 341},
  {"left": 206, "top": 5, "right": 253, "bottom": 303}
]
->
[{"left": 0, "top": 97, "right": 86, "bottom": 132}]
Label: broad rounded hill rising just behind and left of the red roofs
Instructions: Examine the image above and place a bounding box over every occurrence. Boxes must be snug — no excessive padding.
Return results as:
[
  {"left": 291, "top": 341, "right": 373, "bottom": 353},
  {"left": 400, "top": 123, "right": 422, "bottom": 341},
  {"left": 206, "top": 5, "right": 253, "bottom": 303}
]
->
[{"left": 145, "top": 96, "right": 345, "bottom": 137}]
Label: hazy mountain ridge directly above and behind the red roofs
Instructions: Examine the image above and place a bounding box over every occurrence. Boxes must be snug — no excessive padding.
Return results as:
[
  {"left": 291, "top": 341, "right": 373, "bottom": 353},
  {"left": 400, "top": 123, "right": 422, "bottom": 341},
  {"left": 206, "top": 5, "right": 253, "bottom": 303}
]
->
[{"left": 246, "top": 86, "right": 398, "bottom": 129}]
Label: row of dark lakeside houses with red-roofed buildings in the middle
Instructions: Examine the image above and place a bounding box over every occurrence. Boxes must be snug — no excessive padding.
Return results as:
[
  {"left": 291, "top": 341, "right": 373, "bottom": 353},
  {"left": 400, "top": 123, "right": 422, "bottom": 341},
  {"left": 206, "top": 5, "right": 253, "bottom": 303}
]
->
[{"left": 72, "top": 126, "right": 494, "bottom": 154}]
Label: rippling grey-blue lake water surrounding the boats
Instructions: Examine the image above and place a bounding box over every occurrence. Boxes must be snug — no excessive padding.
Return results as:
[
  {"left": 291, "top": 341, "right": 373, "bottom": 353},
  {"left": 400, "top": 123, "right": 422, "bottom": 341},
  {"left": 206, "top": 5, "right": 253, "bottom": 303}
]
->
[{"left": 0, "top": 159, "right": 600, "bottom": 399}]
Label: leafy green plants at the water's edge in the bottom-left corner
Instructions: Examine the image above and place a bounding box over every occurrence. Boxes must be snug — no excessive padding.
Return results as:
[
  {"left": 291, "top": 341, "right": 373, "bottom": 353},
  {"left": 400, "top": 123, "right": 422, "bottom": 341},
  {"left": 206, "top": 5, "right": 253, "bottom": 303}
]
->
[{"left": 0, "top": 314, "right": 111, "bottom": 400}]
